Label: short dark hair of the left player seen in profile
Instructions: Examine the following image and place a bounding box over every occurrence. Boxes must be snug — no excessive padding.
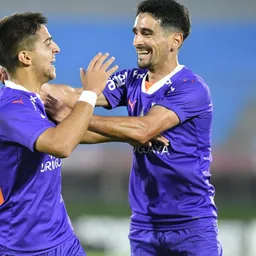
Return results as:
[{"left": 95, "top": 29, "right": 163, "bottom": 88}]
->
[{"left": 0, "top": 12, "right": 47, "bottom": 72}]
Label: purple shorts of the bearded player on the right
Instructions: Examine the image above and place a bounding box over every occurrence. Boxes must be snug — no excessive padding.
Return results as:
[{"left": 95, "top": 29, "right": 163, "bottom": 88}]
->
[{"left": 129, "top": 219, "right": 222, "bottom": 256}]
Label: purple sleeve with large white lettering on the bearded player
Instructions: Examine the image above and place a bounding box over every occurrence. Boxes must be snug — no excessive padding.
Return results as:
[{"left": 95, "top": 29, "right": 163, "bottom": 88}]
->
[{"left": 103, "top": 69, "right": 129, "bottom": 108}]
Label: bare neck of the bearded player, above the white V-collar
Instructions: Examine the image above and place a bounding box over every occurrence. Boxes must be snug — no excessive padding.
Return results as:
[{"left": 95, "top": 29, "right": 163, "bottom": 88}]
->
[{"left": 148, "top": 57, "right": 179, "bottom": 83}]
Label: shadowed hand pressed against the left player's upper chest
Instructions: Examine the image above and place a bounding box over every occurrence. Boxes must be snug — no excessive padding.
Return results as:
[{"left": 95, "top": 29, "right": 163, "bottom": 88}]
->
[{"left": 43, "top": 94, "right": 72, "bottom": 123}]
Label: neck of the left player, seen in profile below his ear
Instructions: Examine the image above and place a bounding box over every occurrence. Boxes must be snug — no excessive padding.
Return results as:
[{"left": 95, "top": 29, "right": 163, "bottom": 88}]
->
[{"left": 9, "top": 68, "right": 43, "bottom": 94}]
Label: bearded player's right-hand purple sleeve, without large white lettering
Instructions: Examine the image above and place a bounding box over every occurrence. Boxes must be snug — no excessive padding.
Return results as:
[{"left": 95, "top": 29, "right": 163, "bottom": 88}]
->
[{"left": 156, "top": 81, "right": 212, "bottom": 123}]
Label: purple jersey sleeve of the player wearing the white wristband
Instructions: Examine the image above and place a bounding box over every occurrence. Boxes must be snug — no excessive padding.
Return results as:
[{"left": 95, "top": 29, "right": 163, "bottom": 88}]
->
[{"left": 0, "top": 100, "right": 55, "bottom": 151}]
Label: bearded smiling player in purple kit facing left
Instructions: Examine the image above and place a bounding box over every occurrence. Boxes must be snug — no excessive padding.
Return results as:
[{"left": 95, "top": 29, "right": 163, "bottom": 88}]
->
[{"left": 89, "top": 0, "right": 222, "bottom": 253}]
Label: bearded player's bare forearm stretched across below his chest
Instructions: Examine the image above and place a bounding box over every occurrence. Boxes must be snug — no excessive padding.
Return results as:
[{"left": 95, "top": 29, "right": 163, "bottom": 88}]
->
[{"left": 88, "top": 116, "right": 152, "bottom": 144}]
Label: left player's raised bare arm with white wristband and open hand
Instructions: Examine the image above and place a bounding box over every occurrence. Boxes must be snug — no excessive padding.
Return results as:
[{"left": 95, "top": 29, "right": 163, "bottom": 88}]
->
[{"left": 35, "top": 54, "right": 118, "bottom": 158}]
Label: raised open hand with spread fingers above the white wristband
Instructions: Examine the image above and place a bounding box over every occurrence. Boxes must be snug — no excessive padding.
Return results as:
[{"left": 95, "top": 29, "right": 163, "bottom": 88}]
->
[{"left": 80, "top": 53, "right": 118, "bottom": 95}]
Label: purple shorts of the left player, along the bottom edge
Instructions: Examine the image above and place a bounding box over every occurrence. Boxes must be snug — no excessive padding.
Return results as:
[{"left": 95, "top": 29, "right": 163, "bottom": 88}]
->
[{"left": 0, "top": 236, "right": 86, "bottom": 256}]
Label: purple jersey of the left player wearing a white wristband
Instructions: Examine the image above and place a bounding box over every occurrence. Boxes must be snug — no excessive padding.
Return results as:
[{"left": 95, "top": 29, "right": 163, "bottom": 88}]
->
[{"left": 0, "top": 81, "right": 73, "bottom": 252}]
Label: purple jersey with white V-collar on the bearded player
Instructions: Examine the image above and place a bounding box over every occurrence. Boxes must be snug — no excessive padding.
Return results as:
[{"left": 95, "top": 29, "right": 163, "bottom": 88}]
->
[{"left": 103, "top": 65, "right": 217, "bottom": 230}]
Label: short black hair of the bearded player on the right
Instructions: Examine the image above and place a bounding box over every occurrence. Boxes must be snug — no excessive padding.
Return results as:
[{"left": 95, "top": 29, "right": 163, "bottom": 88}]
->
[{"left": 136, "top": 0, "right": 191, "bottom": 40}]
